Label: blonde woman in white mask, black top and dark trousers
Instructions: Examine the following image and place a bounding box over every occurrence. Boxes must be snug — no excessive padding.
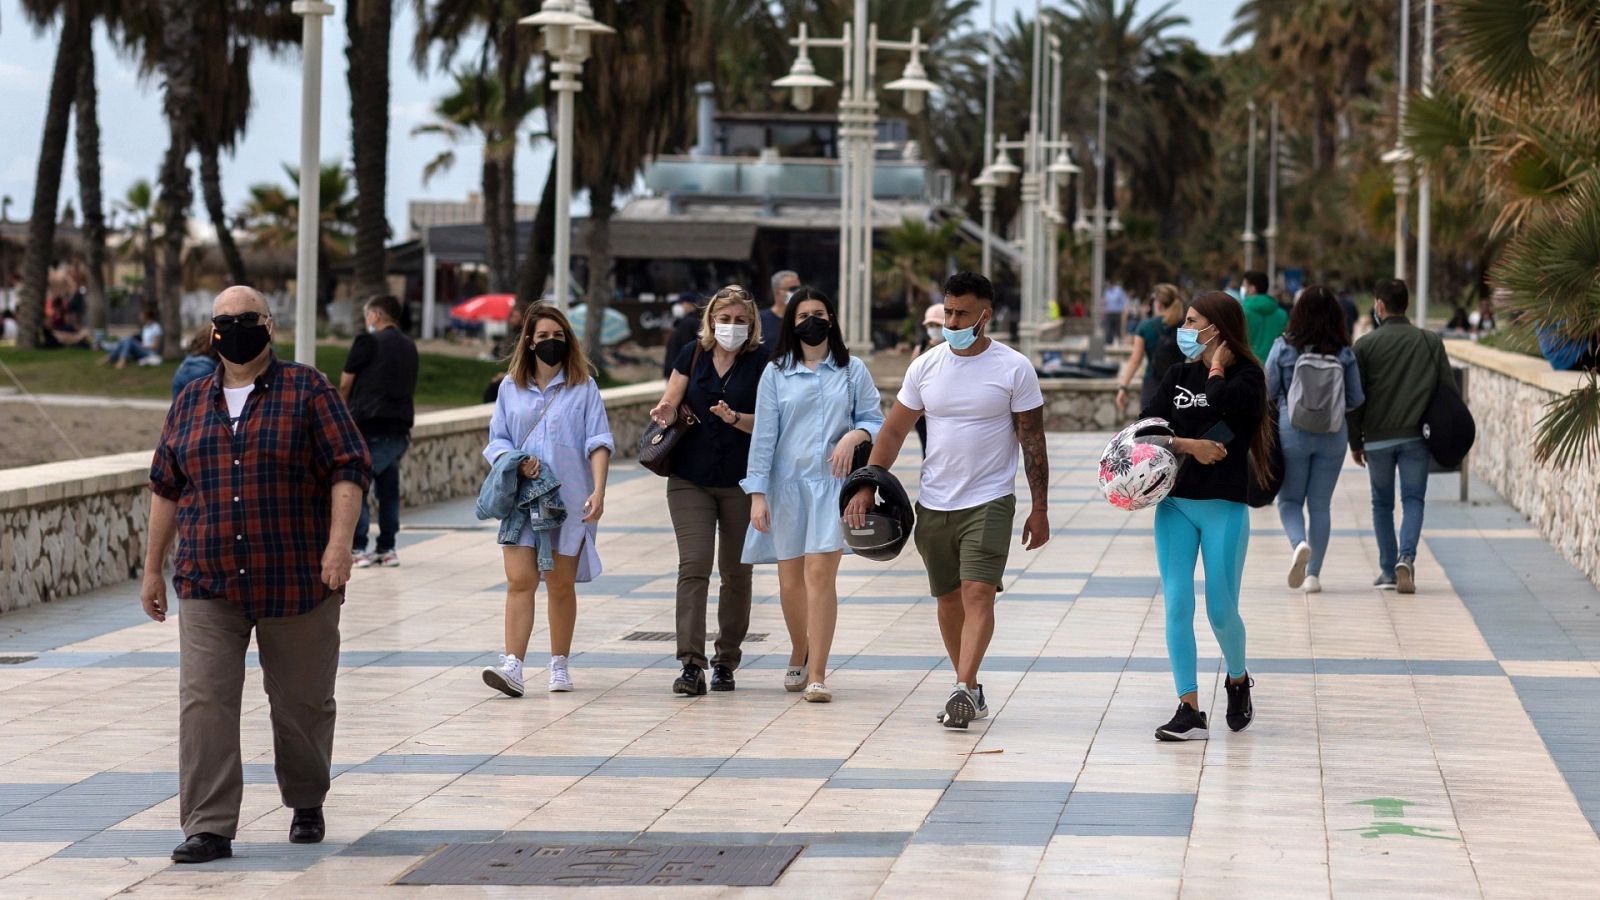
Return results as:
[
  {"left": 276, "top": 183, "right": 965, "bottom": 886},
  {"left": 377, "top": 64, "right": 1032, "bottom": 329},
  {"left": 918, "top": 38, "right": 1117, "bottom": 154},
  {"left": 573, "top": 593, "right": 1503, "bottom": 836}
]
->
[{"left": 650, "top": 285, "right": 766, "bottom": 697}]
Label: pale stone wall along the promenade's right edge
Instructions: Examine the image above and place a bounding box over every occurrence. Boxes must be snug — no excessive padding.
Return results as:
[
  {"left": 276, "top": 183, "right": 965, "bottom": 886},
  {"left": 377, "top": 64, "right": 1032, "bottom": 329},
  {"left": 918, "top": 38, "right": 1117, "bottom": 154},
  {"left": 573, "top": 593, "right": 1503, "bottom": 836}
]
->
[{"left": 1445, "top": 341, "right": 1600, "bottom": 585}]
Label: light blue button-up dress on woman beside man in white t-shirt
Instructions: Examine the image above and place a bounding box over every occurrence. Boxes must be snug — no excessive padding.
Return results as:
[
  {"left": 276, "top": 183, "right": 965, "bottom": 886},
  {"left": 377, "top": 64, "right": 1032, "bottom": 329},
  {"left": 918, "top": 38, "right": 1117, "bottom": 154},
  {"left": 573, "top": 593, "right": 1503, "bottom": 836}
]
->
[{"left": 739, "top": 357, "right": 883, "bottom": 564}]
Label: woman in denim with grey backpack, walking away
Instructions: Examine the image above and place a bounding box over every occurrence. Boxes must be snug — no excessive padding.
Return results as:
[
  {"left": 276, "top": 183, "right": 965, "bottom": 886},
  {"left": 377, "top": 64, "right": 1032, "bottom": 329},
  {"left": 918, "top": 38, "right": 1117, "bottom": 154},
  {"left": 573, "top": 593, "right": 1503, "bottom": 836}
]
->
[{"left": 1266, "top": 285, "right": 1366, "bottom": 594}]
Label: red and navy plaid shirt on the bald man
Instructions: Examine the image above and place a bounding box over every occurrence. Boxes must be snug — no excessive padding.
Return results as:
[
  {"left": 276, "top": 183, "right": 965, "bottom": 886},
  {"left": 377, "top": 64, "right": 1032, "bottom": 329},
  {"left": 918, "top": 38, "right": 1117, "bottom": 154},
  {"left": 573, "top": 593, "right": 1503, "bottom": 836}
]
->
[{"left": 150, "top": 356, "right": 371, "bottom": 618}]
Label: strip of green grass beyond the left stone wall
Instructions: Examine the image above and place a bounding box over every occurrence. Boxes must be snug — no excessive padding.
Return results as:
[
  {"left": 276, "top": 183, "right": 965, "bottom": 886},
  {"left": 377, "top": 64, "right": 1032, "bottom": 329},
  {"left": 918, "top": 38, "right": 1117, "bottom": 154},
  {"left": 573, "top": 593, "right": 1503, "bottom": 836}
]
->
[{"left": 0, "top": 344, "right": 531, "bottom": 407}]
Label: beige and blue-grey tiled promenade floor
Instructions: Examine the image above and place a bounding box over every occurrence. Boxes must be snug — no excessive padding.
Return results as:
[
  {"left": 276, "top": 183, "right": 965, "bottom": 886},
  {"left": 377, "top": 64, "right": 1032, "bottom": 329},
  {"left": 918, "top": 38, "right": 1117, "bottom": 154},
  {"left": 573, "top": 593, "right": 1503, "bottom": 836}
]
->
[{"left": 0, "top": 436, "right": 1600, "bottom": 900}]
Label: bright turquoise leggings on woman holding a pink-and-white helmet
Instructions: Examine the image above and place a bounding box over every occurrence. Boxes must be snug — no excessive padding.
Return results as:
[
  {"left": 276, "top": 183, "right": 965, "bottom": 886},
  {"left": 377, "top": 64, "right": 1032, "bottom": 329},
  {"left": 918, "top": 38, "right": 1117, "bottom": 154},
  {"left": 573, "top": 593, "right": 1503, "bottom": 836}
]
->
[{"left": 1155, "top": 496, "right": 1250, "bottom": 697}]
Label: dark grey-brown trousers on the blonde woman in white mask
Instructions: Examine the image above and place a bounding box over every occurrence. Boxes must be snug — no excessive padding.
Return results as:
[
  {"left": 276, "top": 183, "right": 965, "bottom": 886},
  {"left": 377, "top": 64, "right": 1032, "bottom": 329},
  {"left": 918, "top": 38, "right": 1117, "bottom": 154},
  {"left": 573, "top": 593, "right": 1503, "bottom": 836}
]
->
[{"left": 667, "top": 476, "right": 750, "bottom": 669}]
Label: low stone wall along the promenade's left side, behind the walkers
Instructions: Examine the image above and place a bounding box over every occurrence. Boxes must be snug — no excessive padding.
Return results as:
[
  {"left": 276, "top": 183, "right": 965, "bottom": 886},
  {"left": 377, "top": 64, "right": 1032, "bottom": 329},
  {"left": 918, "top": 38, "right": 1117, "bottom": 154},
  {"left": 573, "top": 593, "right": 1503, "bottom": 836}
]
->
[{"left": 0, "top": 381, "right": 661, "bottom": 613}]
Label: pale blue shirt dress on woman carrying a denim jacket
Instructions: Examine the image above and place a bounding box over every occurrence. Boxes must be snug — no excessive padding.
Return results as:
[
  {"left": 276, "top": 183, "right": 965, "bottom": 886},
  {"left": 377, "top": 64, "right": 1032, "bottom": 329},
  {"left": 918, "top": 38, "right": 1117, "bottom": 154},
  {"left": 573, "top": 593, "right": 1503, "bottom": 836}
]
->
[{"left": 483, "top": 373, "right": 616, "bottom": 583}]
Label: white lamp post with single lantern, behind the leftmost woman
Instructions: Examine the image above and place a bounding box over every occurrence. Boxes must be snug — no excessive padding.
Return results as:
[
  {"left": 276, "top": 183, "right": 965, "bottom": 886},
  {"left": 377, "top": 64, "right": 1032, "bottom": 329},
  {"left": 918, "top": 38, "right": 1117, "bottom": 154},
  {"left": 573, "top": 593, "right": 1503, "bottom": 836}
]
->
[{"left": 518, "top": 0, "right": 614, "bottom": 309}]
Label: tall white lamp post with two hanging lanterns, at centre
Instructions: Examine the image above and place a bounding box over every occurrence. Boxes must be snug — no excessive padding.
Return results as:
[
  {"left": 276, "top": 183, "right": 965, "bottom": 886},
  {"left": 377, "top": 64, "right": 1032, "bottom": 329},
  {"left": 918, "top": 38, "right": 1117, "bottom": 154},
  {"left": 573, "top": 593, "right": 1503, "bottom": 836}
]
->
[{"left": 773, "top": 0, "right": 938, "bottom": 352}]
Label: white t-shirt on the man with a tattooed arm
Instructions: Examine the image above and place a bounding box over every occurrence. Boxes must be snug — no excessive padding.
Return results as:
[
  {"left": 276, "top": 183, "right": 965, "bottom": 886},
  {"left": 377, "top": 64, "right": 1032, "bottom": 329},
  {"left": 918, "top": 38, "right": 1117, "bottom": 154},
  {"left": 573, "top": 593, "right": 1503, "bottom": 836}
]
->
[{"left": 898, "top": 341, "right": 1045, "bottom": 512}]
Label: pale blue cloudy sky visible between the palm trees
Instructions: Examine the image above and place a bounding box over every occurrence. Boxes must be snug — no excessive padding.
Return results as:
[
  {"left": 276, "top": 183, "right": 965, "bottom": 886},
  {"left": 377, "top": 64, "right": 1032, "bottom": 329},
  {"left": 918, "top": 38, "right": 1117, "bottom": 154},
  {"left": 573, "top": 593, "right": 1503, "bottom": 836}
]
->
[{"left": 0, "top": 0, "right": 1240, "bottom": 239}]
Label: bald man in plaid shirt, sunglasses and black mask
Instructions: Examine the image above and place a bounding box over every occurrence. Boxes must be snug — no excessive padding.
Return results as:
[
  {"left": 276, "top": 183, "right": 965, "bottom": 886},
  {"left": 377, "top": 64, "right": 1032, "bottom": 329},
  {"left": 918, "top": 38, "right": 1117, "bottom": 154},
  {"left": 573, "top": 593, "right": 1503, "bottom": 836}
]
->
[{"left": 141, "top": 287, "right": 371, "bottom": 863}]
